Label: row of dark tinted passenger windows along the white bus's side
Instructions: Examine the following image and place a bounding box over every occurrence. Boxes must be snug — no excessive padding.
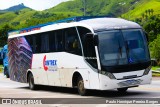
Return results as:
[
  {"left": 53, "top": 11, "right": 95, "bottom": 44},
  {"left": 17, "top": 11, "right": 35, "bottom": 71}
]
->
[{"left": 25, "top": 28, "right": 82, "bottom": 55}]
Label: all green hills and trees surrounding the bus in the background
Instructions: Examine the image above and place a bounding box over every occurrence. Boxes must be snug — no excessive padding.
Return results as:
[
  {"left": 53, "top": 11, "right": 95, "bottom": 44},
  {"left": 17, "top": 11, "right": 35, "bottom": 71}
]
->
[{"left": 0, "top": 0, "right": 160, "bottom": 65}]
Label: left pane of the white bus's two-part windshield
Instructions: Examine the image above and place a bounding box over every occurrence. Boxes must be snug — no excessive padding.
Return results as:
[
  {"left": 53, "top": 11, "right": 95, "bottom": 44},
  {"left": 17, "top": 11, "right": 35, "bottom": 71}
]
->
[{"left": 99, "top": 30, "right": 127, "bottom": 66}]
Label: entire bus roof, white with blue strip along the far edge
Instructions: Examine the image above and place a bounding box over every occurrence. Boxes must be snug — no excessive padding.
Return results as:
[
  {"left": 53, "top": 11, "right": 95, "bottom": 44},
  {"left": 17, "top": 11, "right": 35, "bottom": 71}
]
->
[{"left": 8, "top": 17, "right": 141, "bottom": 38}]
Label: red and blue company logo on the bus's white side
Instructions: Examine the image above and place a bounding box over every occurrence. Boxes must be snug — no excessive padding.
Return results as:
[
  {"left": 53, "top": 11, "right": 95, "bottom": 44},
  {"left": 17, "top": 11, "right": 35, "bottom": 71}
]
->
[{"left": 43, "top": 55, "right": 57, "bottom": 71}]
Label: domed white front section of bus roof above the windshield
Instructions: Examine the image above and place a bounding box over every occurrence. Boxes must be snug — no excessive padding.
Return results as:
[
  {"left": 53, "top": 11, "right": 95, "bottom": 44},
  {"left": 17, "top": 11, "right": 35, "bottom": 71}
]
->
[{"left": 80, "top": 18, "right": 141, "bottom": 32}]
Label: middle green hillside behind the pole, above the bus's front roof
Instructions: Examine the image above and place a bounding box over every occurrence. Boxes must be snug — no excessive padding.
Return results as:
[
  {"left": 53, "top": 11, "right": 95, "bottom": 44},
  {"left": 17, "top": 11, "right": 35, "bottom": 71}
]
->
[{"left": 47, "top": 0, "right": 140, "bottom": 17}]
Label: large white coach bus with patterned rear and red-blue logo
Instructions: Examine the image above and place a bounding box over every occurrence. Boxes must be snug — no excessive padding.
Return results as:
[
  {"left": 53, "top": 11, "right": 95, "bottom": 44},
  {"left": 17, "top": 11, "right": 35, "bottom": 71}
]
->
[{"left": 8, "top": 17, "right": 152, "bottom": 96}]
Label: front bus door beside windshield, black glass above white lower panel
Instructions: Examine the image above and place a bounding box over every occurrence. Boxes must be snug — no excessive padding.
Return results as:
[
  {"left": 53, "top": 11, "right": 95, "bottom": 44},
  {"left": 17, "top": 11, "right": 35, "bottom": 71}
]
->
[{"left": 83, "top": 33, "right": 100, "bottom": 89}]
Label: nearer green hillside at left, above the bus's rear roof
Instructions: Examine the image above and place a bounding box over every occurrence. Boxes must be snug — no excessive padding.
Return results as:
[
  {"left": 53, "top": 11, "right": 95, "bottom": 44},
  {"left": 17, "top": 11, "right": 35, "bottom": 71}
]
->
[{"left": 0, "top": 8, "right": 79, "bottom": 29}]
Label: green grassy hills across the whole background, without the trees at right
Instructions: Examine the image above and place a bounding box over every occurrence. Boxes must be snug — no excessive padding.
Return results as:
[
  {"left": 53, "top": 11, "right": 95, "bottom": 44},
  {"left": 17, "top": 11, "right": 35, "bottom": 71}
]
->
[{"left": 0, "top": 0, "right": 160, "bottom": 29}]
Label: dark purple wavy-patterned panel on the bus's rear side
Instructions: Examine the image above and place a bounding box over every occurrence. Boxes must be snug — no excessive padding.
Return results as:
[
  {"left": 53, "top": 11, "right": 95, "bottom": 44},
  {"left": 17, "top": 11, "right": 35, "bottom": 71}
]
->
[{"left": 8, "top": 37, "right": 32, "bottom": 83}]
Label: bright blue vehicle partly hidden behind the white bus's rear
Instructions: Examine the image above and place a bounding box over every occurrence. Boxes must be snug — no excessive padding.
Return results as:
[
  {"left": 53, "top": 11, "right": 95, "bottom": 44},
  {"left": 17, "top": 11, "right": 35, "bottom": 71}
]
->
[{"left": 1, "top": 44, "right": 9, "bottom": 78}]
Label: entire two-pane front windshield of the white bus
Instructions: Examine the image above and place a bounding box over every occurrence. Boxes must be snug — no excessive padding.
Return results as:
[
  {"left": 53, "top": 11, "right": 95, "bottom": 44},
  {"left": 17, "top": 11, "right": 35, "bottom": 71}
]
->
[{"left": 98, "top": 29, "right": 149, "bottom": 66}]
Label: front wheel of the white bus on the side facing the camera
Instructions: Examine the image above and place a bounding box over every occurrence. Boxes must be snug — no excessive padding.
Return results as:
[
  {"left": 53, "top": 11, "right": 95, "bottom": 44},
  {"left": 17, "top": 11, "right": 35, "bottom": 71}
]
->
[{"left": 77, "top": 77, "right": 87, "bottom": 96}]
